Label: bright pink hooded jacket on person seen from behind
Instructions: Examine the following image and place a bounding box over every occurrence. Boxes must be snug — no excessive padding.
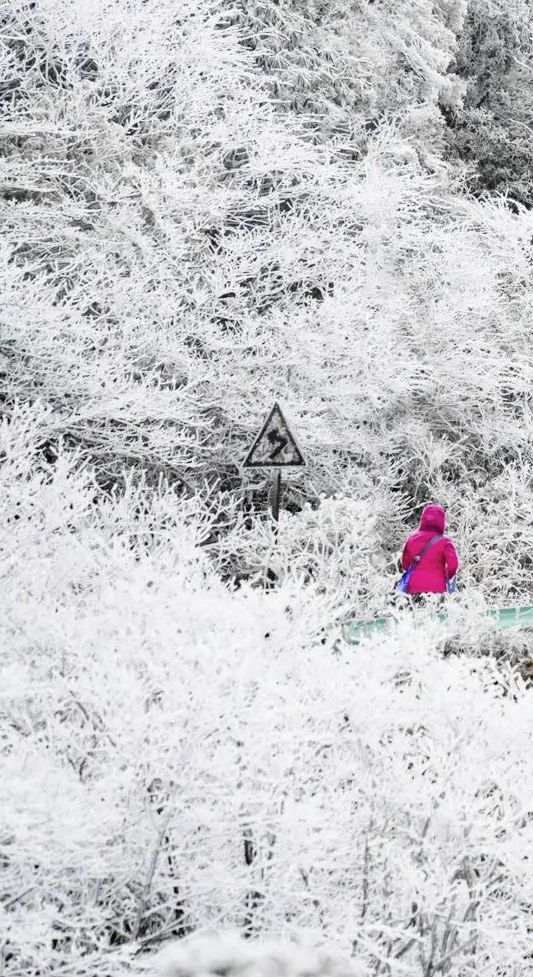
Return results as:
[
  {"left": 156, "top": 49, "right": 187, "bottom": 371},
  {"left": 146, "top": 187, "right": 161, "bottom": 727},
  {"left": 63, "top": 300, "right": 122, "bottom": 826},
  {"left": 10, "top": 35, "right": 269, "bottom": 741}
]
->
[{"left": 402, "top": 505, "right": 459, "bottom": 594}]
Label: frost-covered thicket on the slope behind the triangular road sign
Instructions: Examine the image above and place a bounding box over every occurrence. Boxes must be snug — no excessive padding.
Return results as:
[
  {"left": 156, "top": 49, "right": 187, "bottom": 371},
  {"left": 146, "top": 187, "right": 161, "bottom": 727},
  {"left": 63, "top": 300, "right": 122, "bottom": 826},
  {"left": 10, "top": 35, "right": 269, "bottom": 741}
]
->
[{"left": 0, "top": 0, "right": 533, "bottom": 602}]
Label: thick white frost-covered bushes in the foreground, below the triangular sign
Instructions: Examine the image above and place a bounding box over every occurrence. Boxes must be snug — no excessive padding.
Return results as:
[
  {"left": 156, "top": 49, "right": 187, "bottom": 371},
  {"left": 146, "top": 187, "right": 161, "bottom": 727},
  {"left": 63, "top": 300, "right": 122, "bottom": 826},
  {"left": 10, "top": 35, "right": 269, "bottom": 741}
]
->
[{"left": 0, "top": 408, "right": 533, "bottom": 977}]
